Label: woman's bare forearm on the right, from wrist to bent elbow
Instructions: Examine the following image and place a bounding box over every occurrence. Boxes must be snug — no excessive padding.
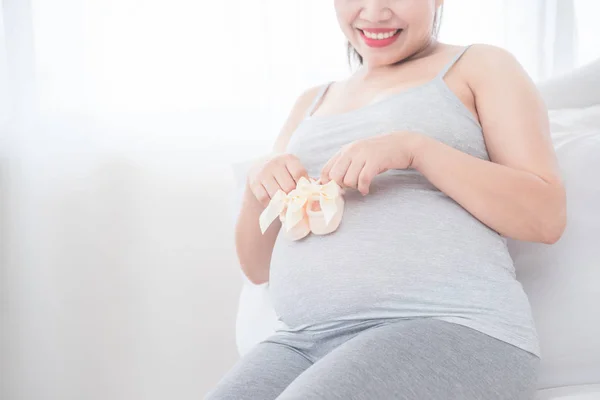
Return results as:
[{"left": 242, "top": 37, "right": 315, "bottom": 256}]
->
[{"left": 412, "top": 138, "right": 566, "bottom": 244}]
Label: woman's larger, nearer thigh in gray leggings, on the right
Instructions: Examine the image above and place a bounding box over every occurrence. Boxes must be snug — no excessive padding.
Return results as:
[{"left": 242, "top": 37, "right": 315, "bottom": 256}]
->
[{"left": 277, "top": 319, "right": 539, "bottom": 400}]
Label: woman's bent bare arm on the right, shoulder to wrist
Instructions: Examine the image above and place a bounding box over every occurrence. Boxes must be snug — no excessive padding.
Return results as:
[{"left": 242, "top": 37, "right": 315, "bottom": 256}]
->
[{"left": 412, "top": 46, "right": 566, "bottom": 244}]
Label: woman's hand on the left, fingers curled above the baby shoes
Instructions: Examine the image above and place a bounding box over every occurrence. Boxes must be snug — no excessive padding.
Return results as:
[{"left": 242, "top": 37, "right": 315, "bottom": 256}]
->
[{"left": 248, "top": 153, "right": 308, "bottom": 207}]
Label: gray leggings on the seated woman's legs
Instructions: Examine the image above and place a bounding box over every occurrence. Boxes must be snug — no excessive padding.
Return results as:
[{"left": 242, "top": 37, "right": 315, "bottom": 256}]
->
[{"left": 206, "top": 319, "right": 539, "bottom": 400}]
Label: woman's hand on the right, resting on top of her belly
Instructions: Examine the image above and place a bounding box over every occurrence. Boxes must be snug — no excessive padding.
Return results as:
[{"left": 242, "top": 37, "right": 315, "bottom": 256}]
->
[{"left": 321, "top": 132, "right": 422, "bottom": 195}]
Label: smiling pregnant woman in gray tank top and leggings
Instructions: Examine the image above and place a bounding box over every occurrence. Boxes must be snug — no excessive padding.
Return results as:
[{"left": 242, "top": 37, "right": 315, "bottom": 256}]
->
[{"left": 208, "top": 0, "right": 566, "bottom": 400}]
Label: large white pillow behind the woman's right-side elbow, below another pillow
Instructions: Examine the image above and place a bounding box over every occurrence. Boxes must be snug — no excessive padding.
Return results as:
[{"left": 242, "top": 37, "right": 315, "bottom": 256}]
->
[{"left": 509, "top": 106, "right": 600, "bottom": 388}]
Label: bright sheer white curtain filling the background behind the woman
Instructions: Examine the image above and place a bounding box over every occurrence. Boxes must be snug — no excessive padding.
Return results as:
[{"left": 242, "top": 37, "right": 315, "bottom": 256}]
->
[{"left": 0, "top": 0, "right": 600, "bottom": 400}]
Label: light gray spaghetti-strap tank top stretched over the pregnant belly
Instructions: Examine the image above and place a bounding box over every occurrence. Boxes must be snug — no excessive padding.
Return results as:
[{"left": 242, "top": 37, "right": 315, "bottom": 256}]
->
[{"left": 269, "top": 48, "right": 540, "bottom": 356}]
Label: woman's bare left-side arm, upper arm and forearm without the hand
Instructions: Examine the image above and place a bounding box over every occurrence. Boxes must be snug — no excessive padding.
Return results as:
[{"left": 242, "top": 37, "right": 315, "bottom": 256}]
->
[{"left": 235, "top": 87, "right": 319, "bottom": 285}]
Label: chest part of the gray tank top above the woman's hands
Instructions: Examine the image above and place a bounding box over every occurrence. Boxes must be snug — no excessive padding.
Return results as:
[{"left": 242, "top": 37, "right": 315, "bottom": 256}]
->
[{"left": 287, "top": 92, "right": 488, "bottom": 176}]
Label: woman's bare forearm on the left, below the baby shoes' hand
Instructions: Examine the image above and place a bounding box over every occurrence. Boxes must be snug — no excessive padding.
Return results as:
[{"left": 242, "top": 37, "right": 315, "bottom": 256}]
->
[{"left": 235, "top": 187, "right": 281, "bottom": 285}]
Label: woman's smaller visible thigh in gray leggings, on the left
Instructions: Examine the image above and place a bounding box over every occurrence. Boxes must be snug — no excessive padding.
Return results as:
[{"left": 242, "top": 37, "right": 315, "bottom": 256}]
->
[{"left": 205, "top": 342, "right": 312, "bottom": 400}]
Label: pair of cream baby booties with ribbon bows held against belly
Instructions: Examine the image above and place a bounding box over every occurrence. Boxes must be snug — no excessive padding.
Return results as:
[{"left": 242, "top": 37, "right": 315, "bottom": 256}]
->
[{"left": 259, "top": 178, "right": 344, "bottom": 240}]
